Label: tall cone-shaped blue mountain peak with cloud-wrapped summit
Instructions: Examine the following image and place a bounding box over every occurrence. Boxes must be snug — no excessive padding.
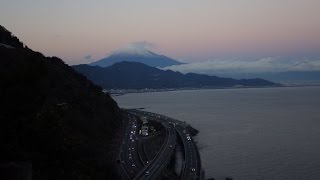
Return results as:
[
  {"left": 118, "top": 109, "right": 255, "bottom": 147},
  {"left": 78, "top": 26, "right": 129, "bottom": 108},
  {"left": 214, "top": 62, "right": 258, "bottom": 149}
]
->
[{"left": 90, "top": 46, "right": 183, "bottom": 67}]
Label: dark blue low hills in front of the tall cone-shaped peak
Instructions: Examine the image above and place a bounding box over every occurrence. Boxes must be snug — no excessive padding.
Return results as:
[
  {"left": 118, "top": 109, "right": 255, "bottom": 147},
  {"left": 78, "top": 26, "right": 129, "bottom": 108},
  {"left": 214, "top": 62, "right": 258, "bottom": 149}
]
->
[{"left": 73, "top": 62, "right": 279, "bottom": 89}]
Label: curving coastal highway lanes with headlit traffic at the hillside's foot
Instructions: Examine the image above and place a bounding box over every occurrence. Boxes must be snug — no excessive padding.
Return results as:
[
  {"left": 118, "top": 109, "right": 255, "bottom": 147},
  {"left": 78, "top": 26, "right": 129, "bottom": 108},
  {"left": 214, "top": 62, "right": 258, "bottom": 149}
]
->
[{"left": 119, "top": 109, "right": 204, "bottom": 180}]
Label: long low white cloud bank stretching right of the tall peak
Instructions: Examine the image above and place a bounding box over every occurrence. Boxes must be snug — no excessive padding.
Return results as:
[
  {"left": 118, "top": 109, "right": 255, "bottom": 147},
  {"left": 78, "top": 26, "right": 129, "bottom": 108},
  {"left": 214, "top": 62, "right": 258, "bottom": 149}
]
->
[{"left": 163, "top": 57, "right": 320, "bottom": 74}]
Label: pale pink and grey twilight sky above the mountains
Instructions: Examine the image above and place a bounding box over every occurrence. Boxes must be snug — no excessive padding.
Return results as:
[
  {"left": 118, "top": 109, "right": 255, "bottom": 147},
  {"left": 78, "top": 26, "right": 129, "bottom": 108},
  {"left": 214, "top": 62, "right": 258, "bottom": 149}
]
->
[{"left": 0, "top": 0, "right": 320, "bottom": 65}]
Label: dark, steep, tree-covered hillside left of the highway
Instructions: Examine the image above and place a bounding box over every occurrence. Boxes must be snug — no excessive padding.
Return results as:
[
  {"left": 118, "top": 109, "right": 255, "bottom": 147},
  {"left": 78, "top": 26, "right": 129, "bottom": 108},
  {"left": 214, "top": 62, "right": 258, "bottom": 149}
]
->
[{"left": 0, "top": 27, "right": 120, "bottom": 180}]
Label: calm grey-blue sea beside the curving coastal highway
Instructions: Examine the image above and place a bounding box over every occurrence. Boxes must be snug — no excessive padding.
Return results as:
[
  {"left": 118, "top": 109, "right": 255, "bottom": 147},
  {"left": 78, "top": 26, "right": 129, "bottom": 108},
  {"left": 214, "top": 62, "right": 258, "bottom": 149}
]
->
[{"left": 115, "top": 87, "right": 320, "bottom": 180}]
